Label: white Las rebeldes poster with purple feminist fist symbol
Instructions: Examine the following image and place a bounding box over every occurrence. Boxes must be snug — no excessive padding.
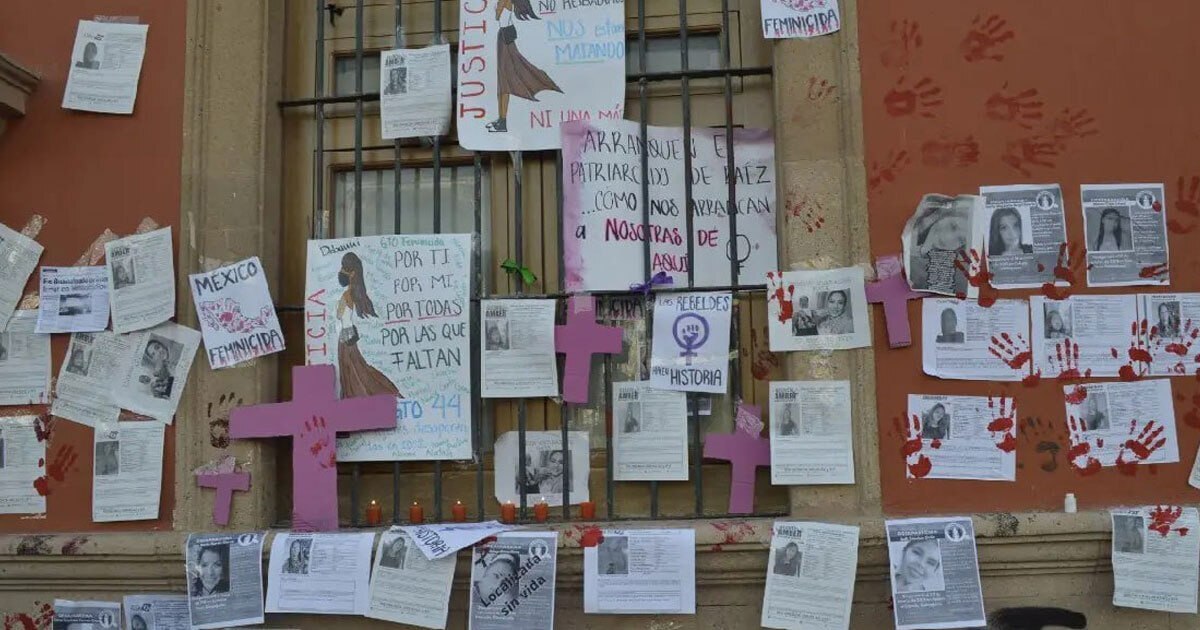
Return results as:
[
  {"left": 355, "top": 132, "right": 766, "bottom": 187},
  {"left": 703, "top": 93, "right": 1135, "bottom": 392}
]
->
[{"left": 650, "top": 292, "right": 733, "bottom": 394}]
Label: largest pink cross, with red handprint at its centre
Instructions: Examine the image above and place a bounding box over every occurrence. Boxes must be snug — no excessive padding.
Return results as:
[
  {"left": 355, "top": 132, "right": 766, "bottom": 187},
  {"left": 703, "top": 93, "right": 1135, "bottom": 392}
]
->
[{"left": 229, "top": 365, "right": 396, "bottom": 532}]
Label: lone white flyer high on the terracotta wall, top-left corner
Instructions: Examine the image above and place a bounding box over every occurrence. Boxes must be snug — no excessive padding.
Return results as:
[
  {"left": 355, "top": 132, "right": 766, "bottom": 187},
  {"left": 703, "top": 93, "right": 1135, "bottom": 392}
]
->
[{"left": 62, "top": 19, "right": 150, "bottom": 114}]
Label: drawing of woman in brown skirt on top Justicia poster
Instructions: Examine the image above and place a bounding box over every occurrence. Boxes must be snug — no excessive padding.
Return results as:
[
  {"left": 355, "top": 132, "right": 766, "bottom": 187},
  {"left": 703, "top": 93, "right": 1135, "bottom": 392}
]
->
[{"left": 487, "top": 0, "right": 563, "bottom": 133}]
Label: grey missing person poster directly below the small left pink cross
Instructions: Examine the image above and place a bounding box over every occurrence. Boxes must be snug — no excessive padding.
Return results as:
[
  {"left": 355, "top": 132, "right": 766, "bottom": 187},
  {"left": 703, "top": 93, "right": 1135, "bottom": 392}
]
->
[{"left": 184, "top": 532, "right": 266, "bottom": 630}]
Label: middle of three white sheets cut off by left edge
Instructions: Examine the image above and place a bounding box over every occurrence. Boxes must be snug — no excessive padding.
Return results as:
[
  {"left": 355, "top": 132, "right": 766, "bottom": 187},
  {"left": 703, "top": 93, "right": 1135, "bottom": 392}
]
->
[{"left": 0, "top": 311, "right": 50, "bottom": 404}]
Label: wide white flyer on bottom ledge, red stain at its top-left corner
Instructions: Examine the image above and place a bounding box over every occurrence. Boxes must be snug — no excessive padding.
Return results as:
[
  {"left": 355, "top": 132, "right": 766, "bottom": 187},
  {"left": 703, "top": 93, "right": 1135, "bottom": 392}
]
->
[{"left": 583, "top": 529, "right": 696, "bottom": 614}]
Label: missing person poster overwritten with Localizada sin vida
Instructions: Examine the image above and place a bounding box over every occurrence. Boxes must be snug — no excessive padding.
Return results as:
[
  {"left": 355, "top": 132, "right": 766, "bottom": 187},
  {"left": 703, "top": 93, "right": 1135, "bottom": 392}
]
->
[{"left": 467, "top": 532, "right": 558, "bottom": 630}]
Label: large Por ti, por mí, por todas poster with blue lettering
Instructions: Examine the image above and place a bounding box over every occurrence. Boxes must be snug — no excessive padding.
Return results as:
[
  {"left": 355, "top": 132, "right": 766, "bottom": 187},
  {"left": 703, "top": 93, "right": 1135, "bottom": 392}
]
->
[{"left": 305, "top": 234, "right": 472, "bottom": 462}]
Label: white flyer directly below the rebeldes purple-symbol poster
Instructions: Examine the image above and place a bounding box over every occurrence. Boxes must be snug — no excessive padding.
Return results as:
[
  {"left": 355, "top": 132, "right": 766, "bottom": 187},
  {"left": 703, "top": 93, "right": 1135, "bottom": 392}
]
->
[{"left": 614, "top": 382, "right": 689, "bottom": 480}]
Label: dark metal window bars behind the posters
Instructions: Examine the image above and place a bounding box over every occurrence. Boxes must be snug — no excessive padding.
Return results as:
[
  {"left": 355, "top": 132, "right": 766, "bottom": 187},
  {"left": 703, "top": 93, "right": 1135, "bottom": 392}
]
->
[{"left": 278, "top": 0, "right": 784, "bottom": 527}]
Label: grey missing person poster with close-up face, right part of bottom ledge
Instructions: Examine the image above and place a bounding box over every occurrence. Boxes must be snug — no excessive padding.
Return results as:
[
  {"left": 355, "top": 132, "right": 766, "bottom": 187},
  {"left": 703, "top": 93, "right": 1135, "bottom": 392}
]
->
[{"left": 886, "top": 516, "right": 988, "bottom": 630}]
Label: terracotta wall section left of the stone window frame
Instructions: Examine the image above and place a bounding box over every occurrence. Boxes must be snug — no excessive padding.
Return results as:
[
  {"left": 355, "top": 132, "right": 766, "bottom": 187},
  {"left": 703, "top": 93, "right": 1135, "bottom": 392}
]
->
[{"left": 0, "top": 0, "right": 187, "bottom": 533}]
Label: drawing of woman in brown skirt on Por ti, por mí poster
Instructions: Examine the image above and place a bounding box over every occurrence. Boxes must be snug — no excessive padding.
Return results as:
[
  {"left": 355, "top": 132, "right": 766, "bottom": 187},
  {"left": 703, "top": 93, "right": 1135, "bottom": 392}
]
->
[{"left": 337, "top": 252, "right": 400, "bottom": 398}]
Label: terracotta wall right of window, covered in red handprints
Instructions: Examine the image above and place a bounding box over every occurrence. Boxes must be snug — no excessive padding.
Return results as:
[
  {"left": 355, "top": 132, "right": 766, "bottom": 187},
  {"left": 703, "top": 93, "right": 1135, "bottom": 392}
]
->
[{"left": 859, "top": 0, "right": 1200, "bottom": 514}]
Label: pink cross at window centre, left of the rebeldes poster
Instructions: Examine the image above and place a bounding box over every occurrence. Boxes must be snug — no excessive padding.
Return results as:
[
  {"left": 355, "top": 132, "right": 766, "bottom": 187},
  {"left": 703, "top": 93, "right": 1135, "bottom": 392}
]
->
[{"left": 554, "top": 295, "right": 622, "bottom": 403}]
